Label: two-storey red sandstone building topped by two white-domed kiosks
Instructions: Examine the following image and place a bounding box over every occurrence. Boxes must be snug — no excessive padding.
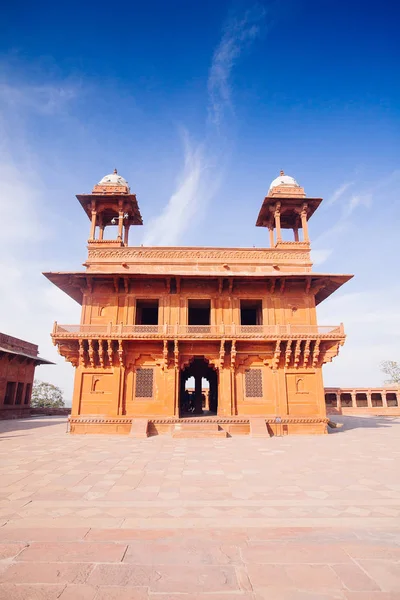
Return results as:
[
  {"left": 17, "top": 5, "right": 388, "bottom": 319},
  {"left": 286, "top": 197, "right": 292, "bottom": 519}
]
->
[{"left": 45, "top": 171, "right": 351, "bottom": 436}]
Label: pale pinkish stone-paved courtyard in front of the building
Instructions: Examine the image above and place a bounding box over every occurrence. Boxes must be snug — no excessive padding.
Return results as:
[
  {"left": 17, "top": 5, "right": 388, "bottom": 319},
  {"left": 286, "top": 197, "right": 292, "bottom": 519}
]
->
[{"left": 0, "top": 417, "right": 400, "bottom": 600}]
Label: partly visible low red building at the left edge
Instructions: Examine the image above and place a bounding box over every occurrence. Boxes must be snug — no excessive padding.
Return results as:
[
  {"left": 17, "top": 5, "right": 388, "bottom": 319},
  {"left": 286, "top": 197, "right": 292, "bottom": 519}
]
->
[{"left": 0, "top": 333, "right": 53, "bottom": 419}]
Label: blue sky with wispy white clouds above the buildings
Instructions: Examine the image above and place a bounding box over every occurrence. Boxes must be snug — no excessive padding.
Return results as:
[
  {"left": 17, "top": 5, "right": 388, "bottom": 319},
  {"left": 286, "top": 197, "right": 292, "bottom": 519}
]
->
[{"left": 0, "top": 0, "right": 400, "bottom": 398}]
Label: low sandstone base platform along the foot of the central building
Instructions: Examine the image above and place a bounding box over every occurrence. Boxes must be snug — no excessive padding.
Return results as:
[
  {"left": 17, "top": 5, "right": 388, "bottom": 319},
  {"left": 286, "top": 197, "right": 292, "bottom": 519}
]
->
[{"left": 69, "top": 415, "right": 329, "bottom": 438}]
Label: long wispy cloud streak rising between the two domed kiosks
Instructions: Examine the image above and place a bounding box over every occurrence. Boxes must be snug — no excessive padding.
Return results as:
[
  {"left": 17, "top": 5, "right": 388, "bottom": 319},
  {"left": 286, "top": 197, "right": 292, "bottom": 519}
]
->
[{"left": 144, "top": 4, "right": 265, "bottom": 245}]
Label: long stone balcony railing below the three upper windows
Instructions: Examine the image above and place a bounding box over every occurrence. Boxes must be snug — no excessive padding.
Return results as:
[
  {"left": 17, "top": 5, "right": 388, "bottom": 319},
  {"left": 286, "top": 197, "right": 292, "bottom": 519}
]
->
[{"left": 52, "top": 322, "right": 345, "bottom": 340}]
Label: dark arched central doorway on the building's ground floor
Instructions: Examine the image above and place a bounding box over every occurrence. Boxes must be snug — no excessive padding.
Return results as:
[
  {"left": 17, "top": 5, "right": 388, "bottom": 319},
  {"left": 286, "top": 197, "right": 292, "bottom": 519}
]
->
[{"left": 179, "top": 356, "right": 218, "bottom": 416}]
